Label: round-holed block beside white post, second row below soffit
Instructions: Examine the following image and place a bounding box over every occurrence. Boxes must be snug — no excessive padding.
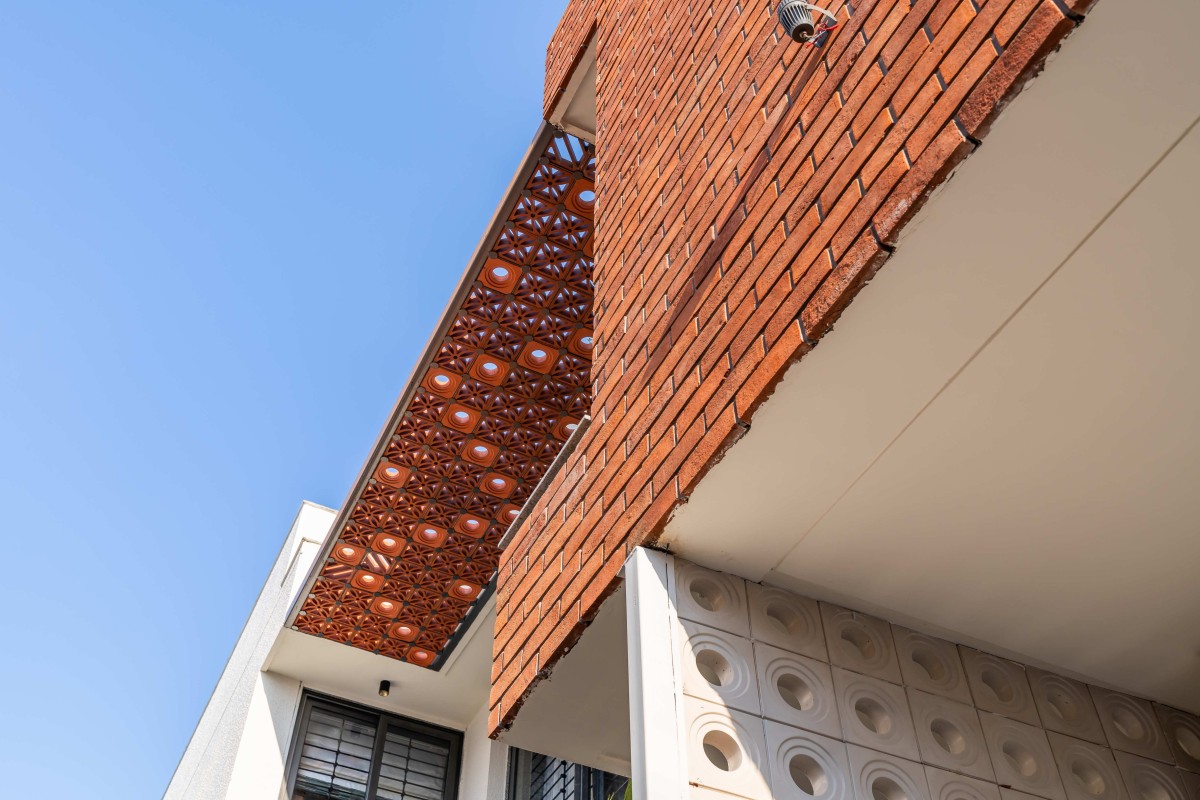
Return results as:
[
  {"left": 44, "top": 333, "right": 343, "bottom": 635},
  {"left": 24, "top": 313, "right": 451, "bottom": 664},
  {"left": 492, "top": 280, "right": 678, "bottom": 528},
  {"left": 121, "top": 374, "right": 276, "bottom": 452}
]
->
[{"left": 679, "top": 620, "right": 762, "bottom": 714}]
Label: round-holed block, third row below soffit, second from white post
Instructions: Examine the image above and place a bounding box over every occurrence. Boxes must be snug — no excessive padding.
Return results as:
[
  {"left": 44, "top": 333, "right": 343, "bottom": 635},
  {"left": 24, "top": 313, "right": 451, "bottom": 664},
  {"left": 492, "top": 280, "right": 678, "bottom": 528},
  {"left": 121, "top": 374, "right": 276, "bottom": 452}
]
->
[{"left": 767, "top": 721, "right": 854, "bottom": 800}]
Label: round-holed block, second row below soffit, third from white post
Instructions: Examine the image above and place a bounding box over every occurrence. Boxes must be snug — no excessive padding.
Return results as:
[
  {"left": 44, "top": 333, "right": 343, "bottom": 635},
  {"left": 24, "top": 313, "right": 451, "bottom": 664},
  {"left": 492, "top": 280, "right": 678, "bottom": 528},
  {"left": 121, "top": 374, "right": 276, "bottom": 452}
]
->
[{"left": 833, "top": 667, "right": 920, "bottom": 762}]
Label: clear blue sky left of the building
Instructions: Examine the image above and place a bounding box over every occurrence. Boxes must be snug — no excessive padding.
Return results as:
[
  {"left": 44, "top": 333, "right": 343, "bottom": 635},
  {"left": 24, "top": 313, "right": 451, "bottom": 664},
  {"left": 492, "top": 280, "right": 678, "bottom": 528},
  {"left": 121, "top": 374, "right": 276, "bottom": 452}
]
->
[{"left": 0, "top": 0, "right": 565, "bottom": 800}]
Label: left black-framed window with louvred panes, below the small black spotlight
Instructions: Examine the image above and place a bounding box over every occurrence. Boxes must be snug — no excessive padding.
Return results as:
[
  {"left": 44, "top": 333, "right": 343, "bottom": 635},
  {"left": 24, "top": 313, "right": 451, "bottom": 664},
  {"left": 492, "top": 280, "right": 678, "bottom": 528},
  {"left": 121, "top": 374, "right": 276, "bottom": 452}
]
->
[{"left": 288, "top": 694, "right": 462, "bottom": 800}]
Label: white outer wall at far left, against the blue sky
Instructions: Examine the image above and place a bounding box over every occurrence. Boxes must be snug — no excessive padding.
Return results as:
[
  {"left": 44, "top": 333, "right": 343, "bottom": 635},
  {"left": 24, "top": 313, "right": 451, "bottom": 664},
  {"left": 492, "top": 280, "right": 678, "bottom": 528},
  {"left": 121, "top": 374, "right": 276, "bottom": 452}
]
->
[{"left": 163, "top": 503, "right": 335, "bottom": 800}]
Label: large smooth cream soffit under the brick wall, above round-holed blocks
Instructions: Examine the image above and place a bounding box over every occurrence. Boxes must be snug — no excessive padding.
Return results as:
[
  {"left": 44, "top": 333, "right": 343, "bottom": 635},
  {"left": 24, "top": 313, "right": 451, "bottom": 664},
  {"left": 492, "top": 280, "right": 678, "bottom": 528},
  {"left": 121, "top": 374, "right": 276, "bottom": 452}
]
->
[{"left": 666, "top": 0, "right": 1200, "bottom": 711}]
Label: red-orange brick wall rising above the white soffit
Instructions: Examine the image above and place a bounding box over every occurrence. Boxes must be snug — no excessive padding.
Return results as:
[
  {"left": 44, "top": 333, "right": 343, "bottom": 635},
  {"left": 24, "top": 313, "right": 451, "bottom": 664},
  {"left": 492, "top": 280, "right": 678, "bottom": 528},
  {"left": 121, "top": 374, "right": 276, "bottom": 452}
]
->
[{"left": 491, "top": 0, "right": 1088, "bottom": 732}]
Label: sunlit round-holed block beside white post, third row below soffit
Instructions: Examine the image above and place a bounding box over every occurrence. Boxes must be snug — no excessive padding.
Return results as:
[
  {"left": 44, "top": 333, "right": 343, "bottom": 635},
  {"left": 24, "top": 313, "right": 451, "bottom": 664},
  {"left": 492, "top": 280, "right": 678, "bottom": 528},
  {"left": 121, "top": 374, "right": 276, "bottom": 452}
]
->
[{"left": 684, "top": 697, "right": 770, "bottom": 800}]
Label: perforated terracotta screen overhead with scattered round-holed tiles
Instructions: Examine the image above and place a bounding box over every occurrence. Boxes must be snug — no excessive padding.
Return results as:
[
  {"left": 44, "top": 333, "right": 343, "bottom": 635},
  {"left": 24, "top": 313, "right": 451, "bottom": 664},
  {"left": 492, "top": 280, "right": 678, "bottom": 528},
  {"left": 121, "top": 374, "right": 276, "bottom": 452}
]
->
[{"left": 294, "top": 134, "right": 595, "bottom": 667}]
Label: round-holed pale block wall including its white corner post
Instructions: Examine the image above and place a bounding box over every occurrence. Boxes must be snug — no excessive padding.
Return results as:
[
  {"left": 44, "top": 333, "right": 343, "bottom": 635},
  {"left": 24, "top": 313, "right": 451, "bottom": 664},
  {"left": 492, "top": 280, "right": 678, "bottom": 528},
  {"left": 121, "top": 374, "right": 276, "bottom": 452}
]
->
[{"left": 626, "top": 551, "right": 1200, "bottom": 800}]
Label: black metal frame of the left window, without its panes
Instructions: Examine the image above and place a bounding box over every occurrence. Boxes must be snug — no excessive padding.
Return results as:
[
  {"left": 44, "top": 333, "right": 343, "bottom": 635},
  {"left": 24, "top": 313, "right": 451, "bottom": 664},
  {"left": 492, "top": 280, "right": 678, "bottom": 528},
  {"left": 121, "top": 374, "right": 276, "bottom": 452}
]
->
[{"left": 287, "top": 690, "right": 463, "bottom": 800}]
